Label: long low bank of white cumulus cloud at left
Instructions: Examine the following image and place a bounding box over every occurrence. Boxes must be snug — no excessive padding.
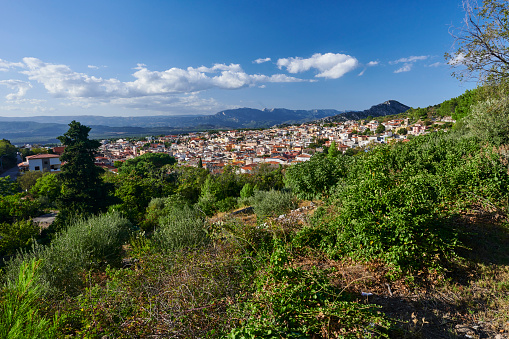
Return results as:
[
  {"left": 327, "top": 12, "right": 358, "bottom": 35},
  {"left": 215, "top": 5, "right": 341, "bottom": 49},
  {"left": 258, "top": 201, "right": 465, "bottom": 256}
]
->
[{"left": 21, "top": 58, "right": 305, "bottom": 98}]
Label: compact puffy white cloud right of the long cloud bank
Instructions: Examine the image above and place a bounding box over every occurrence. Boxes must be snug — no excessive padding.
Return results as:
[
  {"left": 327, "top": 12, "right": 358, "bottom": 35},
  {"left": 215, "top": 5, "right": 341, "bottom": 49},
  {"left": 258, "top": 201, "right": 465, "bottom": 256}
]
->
[{"left": 277, "top": 53, "right": 359, "bottom": 79}]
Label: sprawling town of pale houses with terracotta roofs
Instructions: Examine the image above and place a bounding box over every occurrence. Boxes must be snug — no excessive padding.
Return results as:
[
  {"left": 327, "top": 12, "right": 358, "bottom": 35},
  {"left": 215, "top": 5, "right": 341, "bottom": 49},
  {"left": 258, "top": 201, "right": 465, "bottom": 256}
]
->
[{"left": 18, "top": 117, "right": 452, "bottom": 173}]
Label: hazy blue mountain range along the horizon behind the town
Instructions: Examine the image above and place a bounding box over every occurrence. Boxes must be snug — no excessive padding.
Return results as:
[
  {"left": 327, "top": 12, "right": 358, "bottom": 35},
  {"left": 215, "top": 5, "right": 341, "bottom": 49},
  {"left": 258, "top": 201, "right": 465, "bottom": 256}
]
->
[{"left": 0, "top": 100, "right": 410, "bottom": 144}]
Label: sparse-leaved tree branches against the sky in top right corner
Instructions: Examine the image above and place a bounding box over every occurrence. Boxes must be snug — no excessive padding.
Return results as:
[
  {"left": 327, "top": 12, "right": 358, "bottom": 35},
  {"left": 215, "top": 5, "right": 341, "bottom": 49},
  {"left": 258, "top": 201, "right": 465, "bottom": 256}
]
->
[{"left": 446, "top": 0, "right": 509, "bottom": 83}]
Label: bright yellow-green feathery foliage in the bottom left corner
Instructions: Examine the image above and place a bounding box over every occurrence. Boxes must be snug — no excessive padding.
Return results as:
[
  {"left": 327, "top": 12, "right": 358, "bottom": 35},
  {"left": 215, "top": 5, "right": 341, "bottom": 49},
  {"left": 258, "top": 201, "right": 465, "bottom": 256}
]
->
[{"left": 0, "top": 259, "right": 63, "bottom": 339}]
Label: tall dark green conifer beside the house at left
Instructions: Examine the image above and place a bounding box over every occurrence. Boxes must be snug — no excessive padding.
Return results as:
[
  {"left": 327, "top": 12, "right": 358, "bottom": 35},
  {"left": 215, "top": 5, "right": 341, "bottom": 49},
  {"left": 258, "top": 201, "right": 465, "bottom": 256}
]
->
[{"left": 57, "top": 120, "right": 110, "bottom": 220}]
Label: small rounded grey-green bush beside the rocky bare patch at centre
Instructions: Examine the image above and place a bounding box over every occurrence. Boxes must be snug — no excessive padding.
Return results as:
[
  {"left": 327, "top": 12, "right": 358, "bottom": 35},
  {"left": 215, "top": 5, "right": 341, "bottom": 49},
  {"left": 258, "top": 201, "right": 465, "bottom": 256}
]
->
[{"left": 250, "top": 190, "right": 297, "bottom": 220}]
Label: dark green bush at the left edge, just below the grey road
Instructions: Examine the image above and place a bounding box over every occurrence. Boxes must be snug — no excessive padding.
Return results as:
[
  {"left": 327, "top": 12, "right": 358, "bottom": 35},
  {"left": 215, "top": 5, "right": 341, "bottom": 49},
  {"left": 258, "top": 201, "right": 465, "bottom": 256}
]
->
[{"left": 0, "top": 220, "right": 39, "bottom": 255}]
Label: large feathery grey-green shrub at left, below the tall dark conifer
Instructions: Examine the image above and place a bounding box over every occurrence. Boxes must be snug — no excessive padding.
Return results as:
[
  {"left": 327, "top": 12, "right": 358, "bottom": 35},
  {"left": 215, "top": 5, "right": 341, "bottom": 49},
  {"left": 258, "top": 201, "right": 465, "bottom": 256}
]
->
[{"left": 6, "top": 214, "right": 132, "bottom": 294}]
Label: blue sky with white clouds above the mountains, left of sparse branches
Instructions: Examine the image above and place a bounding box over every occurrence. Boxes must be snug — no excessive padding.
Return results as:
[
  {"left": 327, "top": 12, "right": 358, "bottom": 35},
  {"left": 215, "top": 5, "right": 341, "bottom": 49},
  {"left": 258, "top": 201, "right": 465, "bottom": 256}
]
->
[{"left": 0, "top": 0, "right": 475, "bottom": 116}]
